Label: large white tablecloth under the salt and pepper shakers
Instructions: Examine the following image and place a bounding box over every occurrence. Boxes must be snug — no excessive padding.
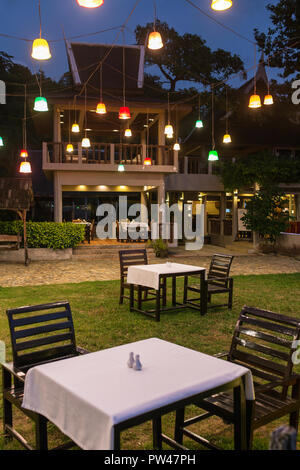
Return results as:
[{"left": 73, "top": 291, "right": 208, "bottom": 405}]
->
[{"left": 23, "top": 338, "right": 254, "bottom": 450}]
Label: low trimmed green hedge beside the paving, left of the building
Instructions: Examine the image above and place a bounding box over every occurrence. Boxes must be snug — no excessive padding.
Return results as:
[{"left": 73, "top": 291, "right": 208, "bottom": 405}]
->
[{"left": 0, "top": 221, "right": 85, "bottom": 250}]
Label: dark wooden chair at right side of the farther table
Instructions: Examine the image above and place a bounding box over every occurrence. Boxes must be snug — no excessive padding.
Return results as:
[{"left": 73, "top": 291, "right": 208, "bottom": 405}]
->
[{"left": 184, "top": 254, "right": 234, "bottom": 310}]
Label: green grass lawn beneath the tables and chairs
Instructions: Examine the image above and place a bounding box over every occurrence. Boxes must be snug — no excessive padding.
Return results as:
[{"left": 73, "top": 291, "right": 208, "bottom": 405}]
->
[{"left": 0, "top": 273, "right": 300, "bottom": 450}]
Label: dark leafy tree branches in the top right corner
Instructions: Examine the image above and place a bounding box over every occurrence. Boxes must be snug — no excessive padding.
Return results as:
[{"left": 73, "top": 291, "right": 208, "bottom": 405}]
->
[{"left": 255, "top": 0, "right": 300, "bottom": 78}]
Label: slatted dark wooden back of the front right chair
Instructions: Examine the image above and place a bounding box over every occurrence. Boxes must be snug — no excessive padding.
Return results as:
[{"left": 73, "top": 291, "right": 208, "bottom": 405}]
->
[{"left": 228, "top": 306, "right": 300, "bottom": 395}]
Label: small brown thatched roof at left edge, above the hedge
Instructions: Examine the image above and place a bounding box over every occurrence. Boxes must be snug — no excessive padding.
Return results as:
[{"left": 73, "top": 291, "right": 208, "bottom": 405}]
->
[{"left": 0, "top": 178, "right": 33, "bottom": 210}]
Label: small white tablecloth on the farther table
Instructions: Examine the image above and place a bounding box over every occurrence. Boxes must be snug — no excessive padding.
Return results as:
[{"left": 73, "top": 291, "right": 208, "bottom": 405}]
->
[{"left": 127, "top": 263, "right": 205, "bottom": 290}]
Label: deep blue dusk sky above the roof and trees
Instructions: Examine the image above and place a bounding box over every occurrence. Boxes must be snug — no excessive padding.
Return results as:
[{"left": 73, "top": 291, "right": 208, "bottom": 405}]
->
[{"left": 0, "top": 0, "right": 277, "bottom": 85}]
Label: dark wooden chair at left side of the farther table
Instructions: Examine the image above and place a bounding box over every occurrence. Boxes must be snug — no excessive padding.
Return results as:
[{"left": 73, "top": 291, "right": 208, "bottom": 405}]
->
[{"left": 119, "top": 249, "right": 166, "bottom": 304}]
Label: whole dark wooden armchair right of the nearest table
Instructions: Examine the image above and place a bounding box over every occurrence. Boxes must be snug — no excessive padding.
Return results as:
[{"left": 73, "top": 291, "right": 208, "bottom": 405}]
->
[{"left": 175, "top": 306, "right": 300, "bottom": 449}]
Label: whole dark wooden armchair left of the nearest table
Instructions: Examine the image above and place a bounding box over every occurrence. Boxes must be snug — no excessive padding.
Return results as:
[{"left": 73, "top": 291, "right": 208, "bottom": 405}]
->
[{"left": 2, "top": 302, "right": 88, "bottom": 450}]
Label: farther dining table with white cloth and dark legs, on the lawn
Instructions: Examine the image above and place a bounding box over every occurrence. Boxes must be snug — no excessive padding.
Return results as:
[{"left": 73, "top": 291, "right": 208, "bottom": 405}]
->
[{"left": 127, "top": 262, "right": 207, "bottom": 322}]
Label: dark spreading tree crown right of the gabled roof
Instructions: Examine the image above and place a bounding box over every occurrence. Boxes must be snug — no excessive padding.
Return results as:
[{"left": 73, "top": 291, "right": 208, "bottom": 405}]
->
[{"left": 135, "top": 21, "right": 244, "bottom": 91}]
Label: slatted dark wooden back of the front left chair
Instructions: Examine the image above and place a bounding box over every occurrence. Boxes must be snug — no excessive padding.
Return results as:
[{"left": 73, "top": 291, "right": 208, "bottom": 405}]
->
[{"left": 6, "top": 302, "right": 77, "bottom": 371}]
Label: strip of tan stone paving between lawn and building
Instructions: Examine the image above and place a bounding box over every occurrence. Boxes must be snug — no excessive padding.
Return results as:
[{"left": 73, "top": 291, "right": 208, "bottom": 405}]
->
[{"left": 0, "top": 247, "right": 300, "bottom": 287}]
